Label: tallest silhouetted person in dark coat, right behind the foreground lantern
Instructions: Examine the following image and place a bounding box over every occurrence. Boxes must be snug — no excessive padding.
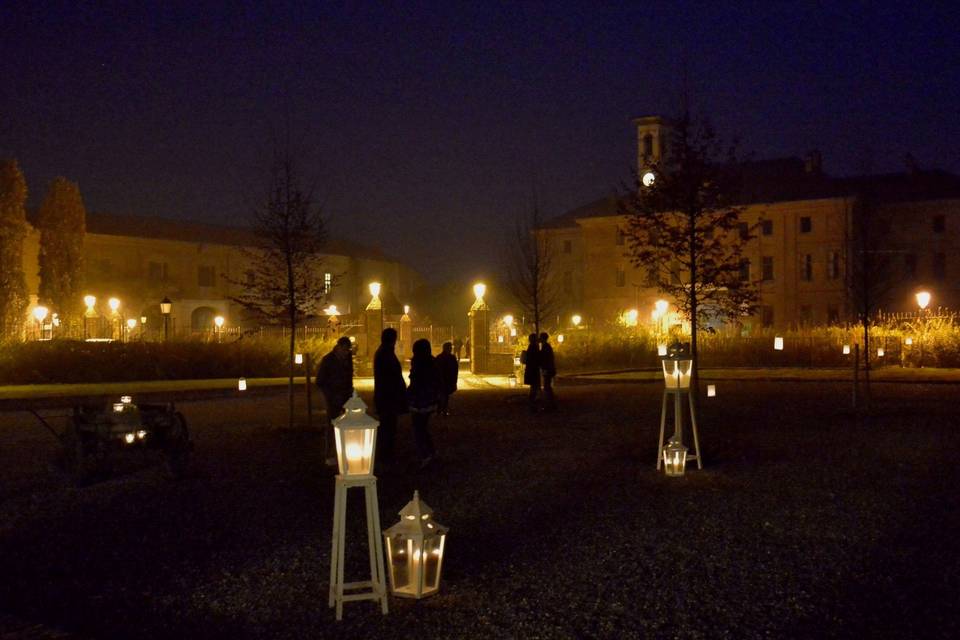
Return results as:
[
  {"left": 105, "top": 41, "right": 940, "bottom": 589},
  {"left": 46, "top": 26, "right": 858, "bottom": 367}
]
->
[{"left": 373, "top": 327, "right": 407, "bottom": 465}]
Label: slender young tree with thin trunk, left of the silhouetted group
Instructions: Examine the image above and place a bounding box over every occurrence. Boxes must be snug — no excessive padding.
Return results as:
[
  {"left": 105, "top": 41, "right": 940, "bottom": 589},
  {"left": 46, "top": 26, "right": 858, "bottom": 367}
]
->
[{"left": 225, "top": 154, "right": 327, "bottom": 427}]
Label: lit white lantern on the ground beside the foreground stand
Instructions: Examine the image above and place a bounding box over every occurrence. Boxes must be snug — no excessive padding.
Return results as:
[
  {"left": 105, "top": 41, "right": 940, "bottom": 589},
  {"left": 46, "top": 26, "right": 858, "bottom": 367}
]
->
[{"left": 383, "top": 491, "right": 447, "bottom": 599}]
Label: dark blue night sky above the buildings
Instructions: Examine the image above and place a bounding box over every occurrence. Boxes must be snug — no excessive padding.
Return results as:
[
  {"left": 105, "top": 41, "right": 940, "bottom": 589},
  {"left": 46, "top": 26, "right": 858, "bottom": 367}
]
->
[{"left": 0, "top": 1, "right": 960, "bottom": 279}]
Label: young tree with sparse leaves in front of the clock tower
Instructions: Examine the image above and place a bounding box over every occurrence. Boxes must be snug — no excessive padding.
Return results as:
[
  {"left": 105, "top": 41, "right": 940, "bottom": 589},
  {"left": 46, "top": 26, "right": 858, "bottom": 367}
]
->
[{"left": 620, "top": 113, "right": 758, "bottom": 376}]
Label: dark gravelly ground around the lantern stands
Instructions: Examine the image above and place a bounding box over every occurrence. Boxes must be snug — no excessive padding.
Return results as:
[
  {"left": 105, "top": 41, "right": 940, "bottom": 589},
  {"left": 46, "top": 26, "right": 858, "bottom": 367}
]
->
[{"left": 0, "top": 381, "right": 960, "bottom": 640}]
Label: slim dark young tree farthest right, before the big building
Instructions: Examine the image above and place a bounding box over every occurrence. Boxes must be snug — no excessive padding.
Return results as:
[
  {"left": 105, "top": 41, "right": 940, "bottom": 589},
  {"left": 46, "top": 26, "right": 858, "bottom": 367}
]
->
[{"left": 844, "top": 188, "right": 900, "bottom": 406}]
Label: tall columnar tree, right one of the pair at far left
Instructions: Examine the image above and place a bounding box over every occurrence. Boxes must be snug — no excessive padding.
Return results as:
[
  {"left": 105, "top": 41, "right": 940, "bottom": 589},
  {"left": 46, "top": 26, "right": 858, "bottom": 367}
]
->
[{"left": 37, "top": 178, "right": 87, "bottom": 327}]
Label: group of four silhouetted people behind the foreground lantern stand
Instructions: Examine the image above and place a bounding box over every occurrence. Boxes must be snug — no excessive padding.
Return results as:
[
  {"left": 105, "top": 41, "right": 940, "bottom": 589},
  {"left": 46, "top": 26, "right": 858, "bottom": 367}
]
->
[{"left": 317, "top": 328, "right": 459, "bottom": 470}]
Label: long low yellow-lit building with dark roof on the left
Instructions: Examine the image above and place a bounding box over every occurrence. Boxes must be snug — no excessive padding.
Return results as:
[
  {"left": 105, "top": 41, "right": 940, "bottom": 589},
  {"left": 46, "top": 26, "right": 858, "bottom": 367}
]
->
[{"left": 23, "top": 213, "right": 421, "bottom": 334}]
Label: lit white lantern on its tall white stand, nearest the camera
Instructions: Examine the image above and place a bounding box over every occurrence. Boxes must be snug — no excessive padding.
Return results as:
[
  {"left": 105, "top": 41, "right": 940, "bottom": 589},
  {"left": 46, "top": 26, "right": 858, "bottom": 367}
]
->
[{"left": 329, "top": 391, "right": 387, "bottom": 620}]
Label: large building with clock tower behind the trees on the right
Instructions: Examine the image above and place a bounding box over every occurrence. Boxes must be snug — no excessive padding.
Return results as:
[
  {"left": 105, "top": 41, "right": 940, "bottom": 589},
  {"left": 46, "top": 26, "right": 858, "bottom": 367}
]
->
[{"left": 539, "top": 116, "right": 960, "bottom": 329}]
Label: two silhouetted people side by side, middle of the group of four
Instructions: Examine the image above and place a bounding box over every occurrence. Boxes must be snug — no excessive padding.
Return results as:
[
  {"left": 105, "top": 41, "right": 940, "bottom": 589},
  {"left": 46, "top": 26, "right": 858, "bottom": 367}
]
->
[{"left": 373, "top": 328, "right": 440, "bottom": 469}]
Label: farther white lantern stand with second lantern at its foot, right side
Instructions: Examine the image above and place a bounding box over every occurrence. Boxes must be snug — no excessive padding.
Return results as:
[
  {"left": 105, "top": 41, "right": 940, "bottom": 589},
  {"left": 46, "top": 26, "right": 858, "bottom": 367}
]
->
[{"left": 657, "top": 347, "right": 703, "bottom": 476}]
